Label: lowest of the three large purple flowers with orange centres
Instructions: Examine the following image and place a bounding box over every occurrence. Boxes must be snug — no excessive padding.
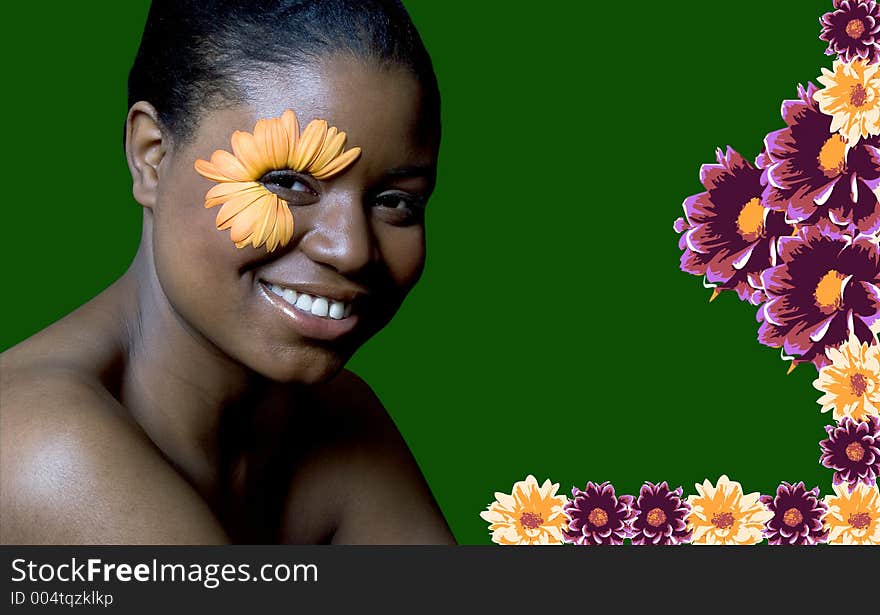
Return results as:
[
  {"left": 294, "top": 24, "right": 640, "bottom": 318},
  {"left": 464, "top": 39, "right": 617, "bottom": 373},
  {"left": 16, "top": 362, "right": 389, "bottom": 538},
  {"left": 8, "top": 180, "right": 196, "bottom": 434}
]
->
[{"left": 758, "top": 226, "right": 880, "bottom": 368}]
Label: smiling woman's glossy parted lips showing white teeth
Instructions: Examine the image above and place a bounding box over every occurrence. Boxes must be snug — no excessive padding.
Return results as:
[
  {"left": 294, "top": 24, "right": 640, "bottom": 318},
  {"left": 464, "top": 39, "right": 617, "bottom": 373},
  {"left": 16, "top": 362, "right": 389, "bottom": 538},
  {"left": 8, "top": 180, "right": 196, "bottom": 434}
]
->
[{"left": 259, "top": 280, "right": 358, "bottom": 340}]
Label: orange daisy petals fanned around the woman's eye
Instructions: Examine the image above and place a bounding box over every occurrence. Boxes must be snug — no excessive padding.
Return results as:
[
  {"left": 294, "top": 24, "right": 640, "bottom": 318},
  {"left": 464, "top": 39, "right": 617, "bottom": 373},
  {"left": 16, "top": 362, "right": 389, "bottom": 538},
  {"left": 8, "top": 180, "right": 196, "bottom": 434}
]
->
[{"left": 195, "top": 109, "right": 361, "bottom": 252}]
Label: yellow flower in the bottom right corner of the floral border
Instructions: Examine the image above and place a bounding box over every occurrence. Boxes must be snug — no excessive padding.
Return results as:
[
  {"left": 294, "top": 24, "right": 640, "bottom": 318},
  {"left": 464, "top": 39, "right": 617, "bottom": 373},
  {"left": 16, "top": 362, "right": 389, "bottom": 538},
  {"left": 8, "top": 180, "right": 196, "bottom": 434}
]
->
[{"left": 824, "top": 483, "right": 880, "bottom": 545}]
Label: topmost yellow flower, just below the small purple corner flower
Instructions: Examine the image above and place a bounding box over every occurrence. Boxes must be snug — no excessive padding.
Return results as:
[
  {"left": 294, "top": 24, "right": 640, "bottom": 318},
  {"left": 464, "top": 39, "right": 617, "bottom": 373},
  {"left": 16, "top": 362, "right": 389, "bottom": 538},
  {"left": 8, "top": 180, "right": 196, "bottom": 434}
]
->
[{"left": 813, "top": 60, "right": 880, "bottom": 147}]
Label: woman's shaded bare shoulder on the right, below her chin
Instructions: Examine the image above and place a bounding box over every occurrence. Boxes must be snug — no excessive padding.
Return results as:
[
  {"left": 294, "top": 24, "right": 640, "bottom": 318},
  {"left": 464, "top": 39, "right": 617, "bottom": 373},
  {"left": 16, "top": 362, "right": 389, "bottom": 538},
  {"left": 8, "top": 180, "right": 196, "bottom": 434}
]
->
[{"left": 285, "top": 371, "right": 454, "bottom": 544}]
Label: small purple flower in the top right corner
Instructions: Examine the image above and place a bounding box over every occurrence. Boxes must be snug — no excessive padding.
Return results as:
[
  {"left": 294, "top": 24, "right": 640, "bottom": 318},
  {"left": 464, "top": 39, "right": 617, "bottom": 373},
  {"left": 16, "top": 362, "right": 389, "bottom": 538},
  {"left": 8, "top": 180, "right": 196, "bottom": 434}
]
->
[{"left": 819, "top": 0, "right": 880, "bottom": 64}]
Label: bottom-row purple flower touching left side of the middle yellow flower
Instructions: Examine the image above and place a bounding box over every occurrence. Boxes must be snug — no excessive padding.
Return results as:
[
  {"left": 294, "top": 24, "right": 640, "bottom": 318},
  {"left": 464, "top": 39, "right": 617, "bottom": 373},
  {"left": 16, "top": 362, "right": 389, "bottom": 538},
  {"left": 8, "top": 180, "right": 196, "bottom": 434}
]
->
[{"left": 632, "top": 481, "right": 693, "bottom": 545}]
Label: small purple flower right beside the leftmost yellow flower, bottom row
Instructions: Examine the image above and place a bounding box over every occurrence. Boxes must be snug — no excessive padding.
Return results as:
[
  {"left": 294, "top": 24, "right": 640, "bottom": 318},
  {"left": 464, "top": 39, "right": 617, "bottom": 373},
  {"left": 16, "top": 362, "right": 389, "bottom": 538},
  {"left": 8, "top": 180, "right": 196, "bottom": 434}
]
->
[{"left": 562, "top": 481, "right": 635, "bottom": 545}]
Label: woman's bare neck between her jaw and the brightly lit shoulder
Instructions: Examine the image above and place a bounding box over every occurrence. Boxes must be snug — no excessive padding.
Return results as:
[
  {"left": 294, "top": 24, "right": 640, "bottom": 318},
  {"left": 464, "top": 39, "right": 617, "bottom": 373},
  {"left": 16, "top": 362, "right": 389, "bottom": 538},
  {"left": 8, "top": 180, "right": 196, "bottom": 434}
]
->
[{"left": 120, "top": 236, "right": 272, "bottom": 499}]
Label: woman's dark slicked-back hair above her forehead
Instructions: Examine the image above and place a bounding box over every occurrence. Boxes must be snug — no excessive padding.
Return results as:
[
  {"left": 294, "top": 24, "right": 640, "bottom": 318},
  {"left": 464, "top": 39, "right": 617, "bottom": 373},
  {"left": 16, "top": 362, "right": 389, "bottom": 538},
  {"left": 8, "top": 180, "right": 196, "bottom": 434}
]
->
[{"left": 128, "top": 0, "right": 439, "bottom": 142}]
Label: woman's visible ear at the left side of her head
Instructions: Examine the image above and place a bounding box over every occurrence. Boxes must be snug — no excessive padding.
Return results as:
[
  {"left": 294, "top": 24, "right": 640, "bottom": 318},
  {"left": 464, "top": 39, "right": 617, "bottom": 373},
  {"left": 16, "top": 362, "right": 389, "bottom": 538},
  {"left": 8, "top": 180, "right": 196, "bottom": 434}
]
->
[{"left": 125, "top": 101, "right": 168, "bottom": 208}]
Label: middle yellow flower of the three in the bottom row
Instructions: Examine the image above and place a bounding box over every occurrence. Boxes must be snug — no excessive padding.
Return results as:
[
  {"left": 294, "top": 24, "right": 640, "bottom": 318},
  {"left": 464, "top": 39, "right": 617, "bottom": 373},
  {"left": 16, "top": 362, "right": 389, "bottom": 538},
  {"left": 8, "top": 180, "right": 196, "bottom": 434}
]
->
[{"left": 687, "top": 475, "right": 773, "bottom": 545}]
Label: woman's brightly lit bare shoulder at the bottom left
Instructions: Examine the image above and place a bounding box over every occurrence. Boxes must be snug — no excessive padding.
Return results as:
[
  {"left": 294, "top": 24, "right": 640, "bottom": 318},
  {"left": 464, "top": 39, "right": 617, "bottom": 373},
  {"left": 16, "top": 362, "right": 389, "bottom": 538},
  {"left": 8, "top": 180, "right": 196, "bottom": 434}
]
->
[{"left": 0, "top": 360, "right": 225, "bottom": 544}]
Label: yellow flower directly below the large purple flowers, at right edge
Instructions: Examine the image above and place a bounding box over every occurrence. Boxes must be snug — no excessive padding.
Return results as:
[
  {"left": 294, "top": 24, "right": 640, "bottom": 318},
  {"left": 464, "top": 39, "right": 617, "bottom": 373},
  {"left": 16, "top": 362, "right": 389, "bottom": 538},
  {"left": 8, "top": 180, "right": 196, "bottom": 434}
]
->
[{"left": 813, "top": 334, "right": 880, "bottom": 421}]
